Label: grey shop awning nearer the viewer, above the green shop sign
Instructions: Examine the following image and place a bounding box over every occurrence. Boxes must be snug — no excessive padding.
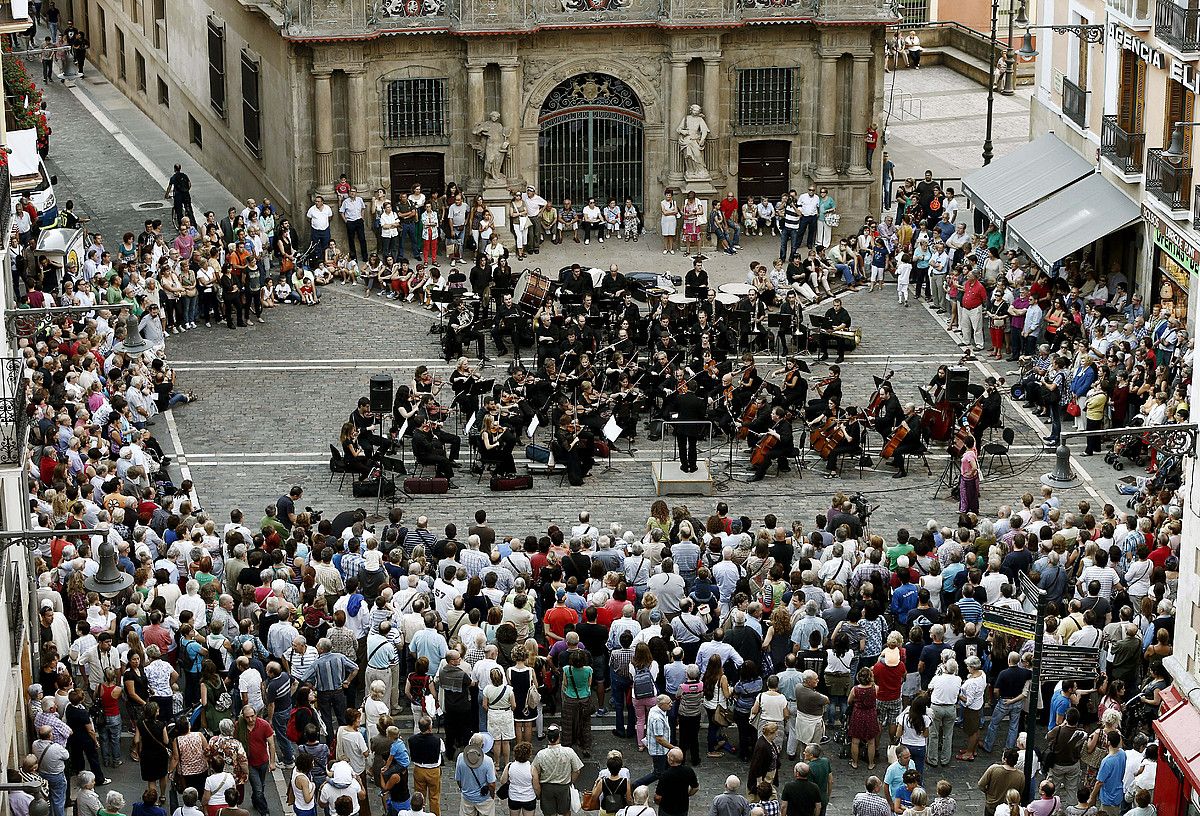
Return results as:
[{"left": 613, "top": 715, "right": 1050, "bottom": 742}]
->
[{"left": 1008, "top": 173, "right": 1141, "bottom": 269}]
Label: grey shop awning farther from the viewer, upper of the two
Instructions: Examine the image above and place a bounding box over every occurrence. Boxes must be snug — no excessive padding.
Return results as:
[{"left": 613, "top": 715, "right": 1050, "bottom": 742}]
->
[{"left": 962, "top": 133, "right": 1096, "bottom": 226}]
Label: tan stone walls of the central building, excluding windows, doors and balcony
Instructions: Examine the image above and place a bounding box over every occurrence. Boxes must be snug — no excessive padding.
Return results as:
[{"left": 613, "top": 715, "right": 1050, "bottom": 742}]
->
[{"left": 68, "top": 0, "right": 883, "bottom": 228}]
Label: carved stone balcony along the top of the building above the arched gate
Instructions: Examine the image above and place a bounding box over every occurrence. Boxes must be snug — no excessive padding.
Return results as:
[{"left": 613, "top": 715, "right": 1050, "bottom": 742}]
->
[{"left": 250, "top": 0, "right": 895, "bottom": 41}]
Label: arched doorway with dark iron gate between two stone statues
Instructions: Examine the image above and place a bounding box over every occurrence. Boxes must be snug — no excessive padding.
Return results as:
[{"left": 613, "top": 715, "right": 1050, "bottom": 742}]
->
[{"left": 538, "top": 73, "right": 646, "bottom": 206}]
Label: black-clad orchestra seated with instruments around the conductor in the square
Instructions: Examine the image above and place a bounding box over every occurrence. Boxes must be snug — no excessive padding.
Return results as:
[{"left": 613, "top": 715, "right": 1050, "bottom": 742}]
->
[{"left": 331, "top": 258, "right": 1003, "bottom": 485}]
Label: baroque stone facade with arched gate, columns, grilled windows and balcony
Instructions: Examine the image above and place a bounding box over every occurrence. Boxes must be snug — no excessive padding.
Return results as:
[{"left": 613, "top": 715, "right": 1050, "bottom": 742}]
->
[{"left": 71, "top": 0, "right": 894, "bottom": 227}]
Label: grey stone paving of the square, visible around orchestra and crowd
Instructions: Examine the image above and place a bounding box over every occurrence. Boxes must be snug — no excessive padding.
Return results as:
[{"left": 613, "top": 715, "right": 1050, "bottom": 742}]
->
[{"left": 37, "top": 59, "right": 1112, "bottom": 815}]
